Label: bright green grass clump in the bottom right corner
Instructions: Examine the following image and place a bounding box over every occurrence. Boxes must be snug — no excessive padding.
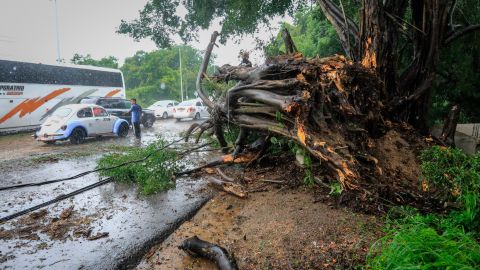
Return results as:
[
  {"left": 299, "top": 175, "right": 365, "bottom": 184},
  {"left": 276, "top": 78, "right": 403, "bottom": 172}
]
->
[{"left": 366, "top": 214, "right": 480, "bottom": 270}]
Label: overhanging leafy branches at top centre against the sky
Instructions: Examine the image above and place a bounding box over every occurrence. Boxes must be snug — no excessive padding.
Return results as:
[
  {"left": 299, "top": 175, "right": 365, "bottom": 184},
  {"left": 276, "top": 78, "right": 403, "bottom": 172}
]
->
[{"left": 118, "top": 0, "right": 310, "bottom": 48}]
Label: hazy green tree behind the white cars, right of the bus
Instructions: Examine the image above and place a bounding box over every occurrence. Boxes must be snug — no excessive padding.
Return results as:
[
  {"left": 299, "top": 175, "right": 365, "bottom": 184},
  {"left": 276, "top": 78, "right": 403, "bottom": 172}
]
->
[{"left": 121, "top": 46, "right": 202, "bottom": 106}]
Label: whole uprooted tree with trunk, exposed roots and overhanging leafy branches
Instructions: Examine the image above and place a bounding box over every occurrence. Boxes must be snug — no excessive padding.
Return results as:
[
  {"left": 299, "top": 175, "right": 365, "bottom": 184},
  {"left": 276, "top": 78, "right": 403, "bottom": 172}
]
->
[{"left": 120, "top": 0, "right": 480, "bottom": 194}]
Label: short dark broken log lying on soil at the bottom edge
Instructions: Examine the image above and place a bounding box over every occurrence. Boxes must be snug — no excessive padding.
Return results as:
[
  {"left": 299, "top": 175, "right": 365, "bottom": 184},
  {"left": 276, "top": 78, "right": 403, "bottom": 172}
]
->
[{"left": 178, "top": 236, "right": 238, "bottom": 270}]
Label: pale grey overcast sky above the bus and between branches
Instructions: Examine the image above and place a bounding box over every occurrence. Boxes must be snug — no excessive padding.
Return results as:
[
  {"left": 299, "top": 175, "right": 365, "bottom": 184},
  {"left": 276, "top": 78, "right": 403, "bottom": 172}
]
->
[{"left": 0, "top": 0, "right": 288, "bottom": 65}]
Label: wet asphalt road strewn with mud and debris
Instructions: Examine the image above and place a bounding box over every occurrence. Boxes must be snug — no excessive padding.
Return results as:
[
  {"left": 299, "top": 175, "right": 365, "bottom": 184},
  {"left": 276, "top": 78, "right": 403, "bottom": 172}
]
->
[{"left": 0, "top": 120, "right": 214, "bottom": 269}]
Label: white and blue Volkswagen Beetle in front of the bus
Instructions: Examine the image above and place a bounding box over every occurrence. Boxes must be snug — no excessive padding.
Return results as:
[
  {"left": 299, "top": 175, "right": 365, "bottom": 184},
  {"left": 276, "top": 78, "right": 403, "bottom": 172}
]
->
[{"left": 34, "top": 104, "right": 130, "bottom": 144}]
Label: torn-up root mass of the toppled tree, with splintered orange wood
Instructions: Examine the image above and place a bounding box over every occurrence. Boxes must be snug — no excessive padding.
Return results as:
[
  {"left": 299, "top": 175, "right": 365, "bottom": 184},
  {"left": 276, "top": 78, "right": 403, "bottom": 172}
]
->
[{"left": 191, "top": 34, "right": 384, "bottom": 192}]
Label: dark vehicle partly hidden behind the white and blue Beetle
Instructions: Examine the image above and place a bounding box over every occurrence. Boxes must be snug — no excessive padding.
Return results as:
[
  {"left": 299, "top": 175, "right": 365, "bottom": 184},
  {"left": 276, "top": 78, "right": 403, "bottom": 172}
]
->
[{"left": 80, "top": 97, "right": 155, "bottom": 128}]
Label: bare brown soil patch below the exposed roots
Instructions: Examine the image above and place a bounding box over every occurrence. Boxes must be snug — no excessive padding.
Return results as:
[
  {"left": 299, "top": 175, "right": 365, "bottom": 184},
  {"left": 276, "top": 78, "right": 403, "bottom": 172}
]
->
[{"left": 137, "top": 187, "right": 381, "bottom": 270}]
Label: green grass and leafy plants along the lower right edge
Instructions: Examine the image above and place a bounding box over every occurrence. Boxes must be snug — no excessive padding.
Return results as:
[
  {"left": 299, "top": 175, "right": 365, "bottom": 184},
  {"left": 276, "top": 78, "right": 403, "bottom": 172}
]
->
[{"left": 365, "top": 147, "right": 480, "bottom": 269}]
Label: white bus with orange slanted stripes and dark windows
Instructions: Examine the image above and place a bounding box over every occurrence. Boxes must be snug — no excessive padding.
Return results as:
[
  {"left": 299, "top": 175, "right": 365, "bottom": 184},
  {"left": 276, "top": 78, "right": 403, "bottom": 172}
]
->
[{"left": 0, "top": 60, "right": 125, "bottom": 134}]
